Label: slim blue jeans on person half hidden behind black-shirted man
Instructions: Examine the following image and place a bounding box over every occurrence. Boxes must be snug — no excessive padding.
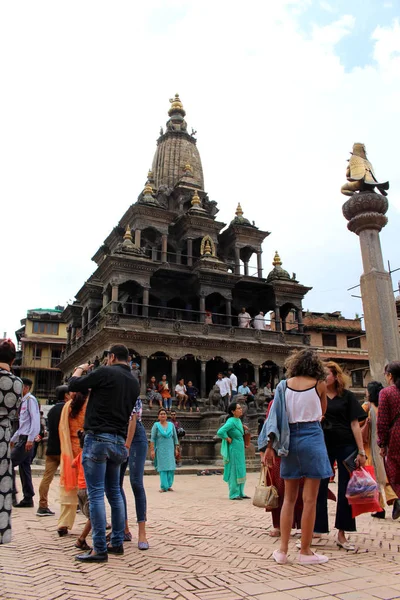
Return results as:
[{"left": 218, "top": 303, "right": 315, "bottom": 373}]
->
[{"left": 129, "top": 422, "right": 148, "bottom": 523}]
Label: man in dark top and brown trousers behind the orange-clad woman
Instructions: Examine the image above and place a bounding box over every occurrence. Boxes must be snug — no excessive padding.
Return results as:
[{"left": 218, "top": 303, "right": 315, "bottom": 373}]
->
[{"left": 36, "top": 385, "right": 71, "bottom": 517}]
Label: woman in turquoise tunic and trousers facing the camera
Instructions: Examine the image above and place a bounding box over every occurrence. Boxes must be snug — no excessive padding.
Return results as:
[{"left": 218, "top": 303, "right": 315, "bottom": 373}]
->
[{"left": 150, "top": 408, "right": 179, "bottom": 492}]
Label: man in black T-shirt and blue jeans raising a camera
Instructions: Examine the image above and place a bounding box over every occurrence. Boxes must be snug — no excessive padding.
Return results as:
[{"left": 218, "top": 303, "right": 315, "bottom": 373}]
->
[{"left": 69, "top": 344, "right": 140, "bottom": 562}]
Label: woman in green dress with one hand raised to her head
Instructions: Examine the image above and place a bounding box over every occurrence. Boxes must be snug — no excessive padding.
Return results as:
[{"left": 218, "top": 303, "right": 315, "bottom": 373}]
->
[{"left": 217, "top": 402, "right": 249, "bottom": 500}]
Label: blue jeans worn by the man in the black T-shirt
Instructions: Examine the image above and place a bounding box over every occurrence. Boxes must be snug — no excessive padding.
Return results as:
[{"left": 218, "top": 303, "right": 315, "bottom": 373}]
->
[{"left": 82, "top": 432, "right": 128, "bottom": 552}]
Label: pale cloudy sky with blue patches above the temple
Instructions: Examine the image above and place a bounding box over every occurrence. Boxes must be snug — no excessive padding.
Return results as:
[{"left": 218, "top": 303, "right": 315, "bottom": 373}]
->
[{"left": 0, "top": 0, "right": 400, "bottom": 336}]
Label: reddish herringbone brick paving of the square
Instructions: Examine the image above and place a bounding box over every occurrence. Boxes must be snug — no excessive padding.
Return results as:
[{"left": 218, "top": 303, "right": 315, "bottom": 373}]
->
[{"left": 0, "top": 473, "right": 400, "bottom": 600}]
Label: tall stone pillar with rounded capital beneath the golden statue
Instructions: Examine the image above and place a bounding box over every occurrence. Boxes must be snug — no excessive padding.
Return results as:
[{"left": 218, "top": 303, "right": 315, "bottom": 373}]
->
[{"left": 343, "top": 192, "right": 400, "bottom": 384}]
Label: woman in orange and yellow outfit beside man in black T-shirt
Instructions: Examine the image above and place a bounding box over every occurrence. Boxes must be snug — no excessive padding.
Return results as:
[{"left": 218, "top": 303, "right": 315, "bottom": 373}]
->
[{"left": 57, "top": 392, "right": 88, "bottom": 537}]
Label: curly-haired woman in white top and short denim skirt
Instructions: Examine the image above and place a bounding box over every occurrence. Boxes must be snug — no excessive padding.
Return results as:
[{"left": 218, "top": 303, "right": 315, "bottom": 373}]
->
[{"left": 259, "top": 349, "right": 332, "bottom": 564}]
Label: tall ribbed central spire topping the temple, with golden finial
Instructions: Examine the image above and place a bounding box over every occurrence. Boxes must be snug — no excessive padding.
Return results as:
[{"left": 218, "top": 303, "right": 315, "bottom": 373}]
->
[{"left": 152, "top": 94, "right": 204, "bottom": 190}]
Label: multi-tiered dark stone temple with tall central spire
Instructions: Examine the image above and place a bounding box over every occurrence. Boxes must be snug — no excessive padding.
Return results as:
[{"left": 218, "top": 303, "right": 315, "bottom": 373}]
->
[{"left": 60, "top": 94, "right": 310, "bottom": 398}]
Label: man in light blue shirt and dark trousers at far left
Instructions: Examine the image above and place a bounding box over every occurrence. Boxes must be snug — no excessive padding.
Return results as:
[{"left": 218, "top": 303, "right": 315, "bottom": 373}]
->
[{"left": 11, "top": 377, "right": 40, "bottom": 508}]
